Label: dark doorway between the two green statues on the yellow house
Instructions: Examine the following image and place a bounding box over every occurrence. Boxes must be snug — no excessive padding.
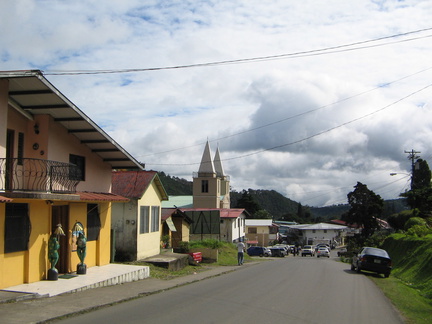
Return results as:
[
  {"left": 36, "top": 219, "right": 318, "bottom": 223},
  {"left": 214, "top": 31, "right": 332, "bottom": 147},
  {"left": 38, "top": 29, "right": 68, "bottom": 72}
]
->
[{"left": 51, "top": 205, "right": 70, "bottom": 273}]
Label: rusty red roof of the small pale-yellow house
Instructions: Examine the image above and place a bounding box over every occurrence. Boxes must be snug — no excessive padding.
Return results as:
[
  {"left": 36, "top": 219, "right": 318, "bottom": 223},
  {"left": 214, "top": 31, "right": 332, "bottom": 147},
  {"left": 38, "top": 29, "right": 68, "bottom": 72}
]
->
[{"left": 111, "top": 171, "right": 168, "bottom": 200}]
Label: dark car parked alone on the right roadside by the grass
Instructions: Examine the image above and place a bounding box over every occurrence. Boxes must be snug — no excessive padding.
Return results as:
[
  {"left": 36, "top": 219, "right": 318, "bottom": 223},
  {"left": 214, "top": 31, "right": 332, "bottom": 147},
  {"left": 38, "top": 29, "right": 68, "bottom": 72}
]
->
[{"left": 351, "top": 247, "right": 392, "bottom": 278}]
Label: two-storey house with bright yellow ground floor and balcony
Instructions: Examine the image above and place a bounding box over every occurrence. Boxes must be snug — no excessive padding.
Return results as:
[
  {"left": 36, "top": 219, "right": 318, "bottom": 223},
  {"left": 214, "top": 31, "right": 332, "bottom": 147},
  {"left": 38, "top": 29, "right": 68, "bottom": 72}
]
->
[{"left": 0, "top": 70, "right": 142, "bottom": 288}]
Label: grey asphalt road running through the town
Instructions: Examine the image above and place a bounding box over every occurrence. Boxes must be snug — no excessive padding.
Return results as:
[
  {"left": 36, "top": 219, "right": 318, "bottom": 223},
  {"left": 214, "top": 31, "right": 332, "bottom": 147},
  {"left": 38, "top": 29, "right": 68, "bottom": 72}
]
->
[{"left": 60, "top": 256, "right": 403, "bottom": 324}]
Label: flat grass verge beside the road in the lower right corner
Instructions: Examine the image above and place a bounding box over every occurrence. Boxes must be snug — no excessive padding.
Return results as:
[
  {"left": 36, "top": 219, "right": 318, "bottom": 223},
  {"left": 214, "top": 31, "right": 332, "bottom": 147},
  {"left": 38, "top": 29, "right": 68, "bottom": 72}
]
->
[{"left": 369, "top": 276, "right": 432, "bottom": 324}]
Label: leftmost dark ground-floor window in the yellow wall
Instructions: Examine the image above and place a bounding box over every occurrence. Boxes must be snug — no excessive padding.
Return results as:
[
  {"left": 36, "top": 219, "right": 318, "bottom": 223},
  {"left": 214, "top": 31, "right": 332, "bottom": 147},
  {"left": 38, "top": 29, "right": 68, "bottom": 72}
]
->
[{"left": 4, "top": 204, "right": 31, "bottom": 253}]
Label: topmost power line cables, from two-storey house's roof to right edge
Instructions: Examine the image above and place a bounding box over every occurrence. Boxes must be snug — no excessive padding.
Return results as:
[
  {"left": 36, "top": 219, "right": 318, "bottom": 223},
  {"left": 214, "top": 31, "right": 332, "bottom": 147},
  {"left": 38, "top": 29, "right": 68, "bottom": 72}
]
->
[{"left": 44, "top": 27, "right": 432, "bottom": 75}]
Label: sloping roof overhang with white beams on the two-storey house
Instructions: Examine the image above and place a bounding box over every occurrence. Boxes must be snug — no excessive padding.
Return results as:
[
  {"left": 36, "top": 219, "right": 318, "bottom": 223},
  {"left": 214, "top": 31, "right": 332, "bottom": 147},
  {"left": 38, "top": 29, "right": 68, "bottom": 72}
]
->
[{"left": 0, "top": 70, "right": 143, "bottom": 170}]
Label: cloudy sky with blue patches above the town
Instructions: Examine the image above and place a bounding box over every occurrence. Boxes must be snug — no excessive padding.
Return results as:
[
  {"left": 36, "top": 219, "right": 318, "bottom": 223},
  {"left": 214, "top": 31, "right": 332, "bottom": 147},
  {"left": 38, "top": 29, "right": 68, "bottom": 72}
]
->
[{"left": 0, "top": 0, "right": 432, "bottom": 207}]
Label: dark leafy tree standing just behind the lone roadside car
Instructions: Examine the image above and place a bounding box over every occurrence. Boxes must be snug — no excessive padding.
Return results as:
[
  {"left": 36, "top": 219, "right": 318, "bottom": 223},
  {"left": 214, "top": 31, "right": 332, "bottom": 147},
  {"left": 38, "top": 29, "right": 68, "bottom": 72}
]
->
[{"left": 344, "top": 182, "right": 384, "bottom": 238}]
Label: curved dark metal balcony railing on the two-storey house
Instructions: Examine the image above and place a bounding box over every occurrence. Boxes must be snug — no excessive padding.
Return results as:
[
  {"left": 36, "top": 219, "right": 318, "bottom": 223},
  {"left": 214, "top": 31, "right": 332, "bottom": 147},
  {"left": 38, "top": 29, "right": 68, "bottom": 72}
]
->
[{"left": 0, "top": 158, "right": 81, "bottom": 193}]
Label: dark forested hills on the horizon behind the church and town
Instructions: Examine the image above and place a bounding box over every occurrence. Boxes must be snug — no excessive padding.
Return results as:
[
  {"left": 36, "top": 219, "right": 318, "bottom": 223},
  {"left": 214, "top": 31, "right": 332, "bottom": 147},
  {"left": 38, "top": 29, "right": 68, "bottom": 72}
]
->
[{"left": 158, "top": 172, "right": 407, "bottom": 222}]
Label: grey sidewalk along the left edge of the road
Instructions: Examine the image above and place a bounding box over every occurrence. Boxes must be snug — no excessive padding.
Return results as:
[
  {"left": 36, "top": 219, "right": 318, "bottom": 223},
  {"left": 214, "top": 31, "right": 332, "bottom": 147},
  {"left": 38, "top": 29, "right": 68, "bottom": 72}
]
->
[{"left": 0, "top": 262, "right": 256, "bottom": 324}]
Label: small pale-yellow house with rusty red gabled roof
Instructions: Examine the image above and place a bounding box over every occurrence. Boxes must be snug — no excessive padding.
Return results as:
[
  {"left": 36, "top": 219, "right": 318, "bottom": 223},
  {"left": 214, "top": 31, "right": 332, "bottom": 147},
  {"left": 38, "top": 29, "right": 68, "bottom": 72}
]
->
[{"left": 112, "top": 171, "right": 168, "bottom": 261}]
